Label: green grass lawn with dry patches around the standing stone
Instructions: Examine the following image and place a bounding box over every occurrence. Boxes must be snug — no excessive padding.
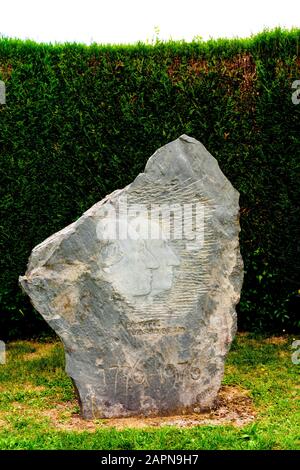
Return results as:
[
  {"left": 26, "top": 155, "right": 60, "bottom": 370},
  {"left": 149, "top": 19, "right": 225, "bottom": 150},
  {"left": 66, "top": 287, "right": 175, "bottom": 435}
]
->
[{"left": 0, "top": 334, "right": 300, "bottom": 450}]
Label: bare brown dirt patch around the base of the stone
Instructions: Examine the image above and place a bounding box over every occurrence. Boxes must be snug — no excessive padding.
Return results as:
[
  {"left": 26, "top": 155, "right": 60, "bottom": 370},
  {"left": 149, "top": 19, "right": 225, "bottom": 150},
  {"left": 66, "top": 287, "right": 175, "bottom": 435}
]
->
[{"left": 42, "top": 386, "right": 256, "bottom": 431}]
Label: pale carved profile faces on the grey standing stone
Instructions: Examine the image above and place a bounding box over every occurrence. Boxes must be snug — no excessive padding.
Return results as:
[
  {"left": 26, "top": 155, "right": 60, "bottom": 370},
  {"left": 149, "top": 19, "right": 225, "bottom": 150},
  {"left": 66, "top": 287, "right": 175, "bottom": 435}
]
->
[{"left": 98, "top": 218, "right": 180, "bottom": 300}]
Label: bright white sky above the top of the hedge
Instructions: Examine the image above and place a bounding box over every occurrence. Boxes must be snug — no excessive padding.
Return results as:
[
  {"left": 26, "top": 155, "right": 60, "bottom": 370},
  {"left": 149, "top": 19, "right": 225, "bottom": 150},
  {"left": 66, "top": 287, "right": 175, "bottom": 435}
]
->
[{"left": 0, "top": 0, "right": 300, "bottom": 44}]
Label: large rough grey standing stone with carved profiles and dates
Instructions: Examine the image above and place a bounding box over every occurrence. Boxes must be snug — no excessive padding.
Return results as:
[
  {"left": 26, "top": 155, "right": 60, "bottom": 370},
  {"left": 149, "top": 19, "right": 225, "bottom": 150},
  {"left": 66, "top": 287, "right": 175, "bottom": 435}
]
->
[{"left": 20, "top": 135, "right": 243, "bottom": 418}]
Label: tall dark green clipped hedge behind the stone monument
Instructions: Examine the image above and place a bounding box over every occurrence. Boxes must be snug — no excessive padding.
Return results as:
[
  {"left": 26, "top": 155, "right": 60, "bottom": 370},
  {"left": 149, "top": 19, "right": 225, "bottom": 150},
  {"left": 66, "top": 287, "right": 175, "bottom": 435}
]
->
[{"left": 0, "top": 29, "right": 300, "bottom": 338}]
